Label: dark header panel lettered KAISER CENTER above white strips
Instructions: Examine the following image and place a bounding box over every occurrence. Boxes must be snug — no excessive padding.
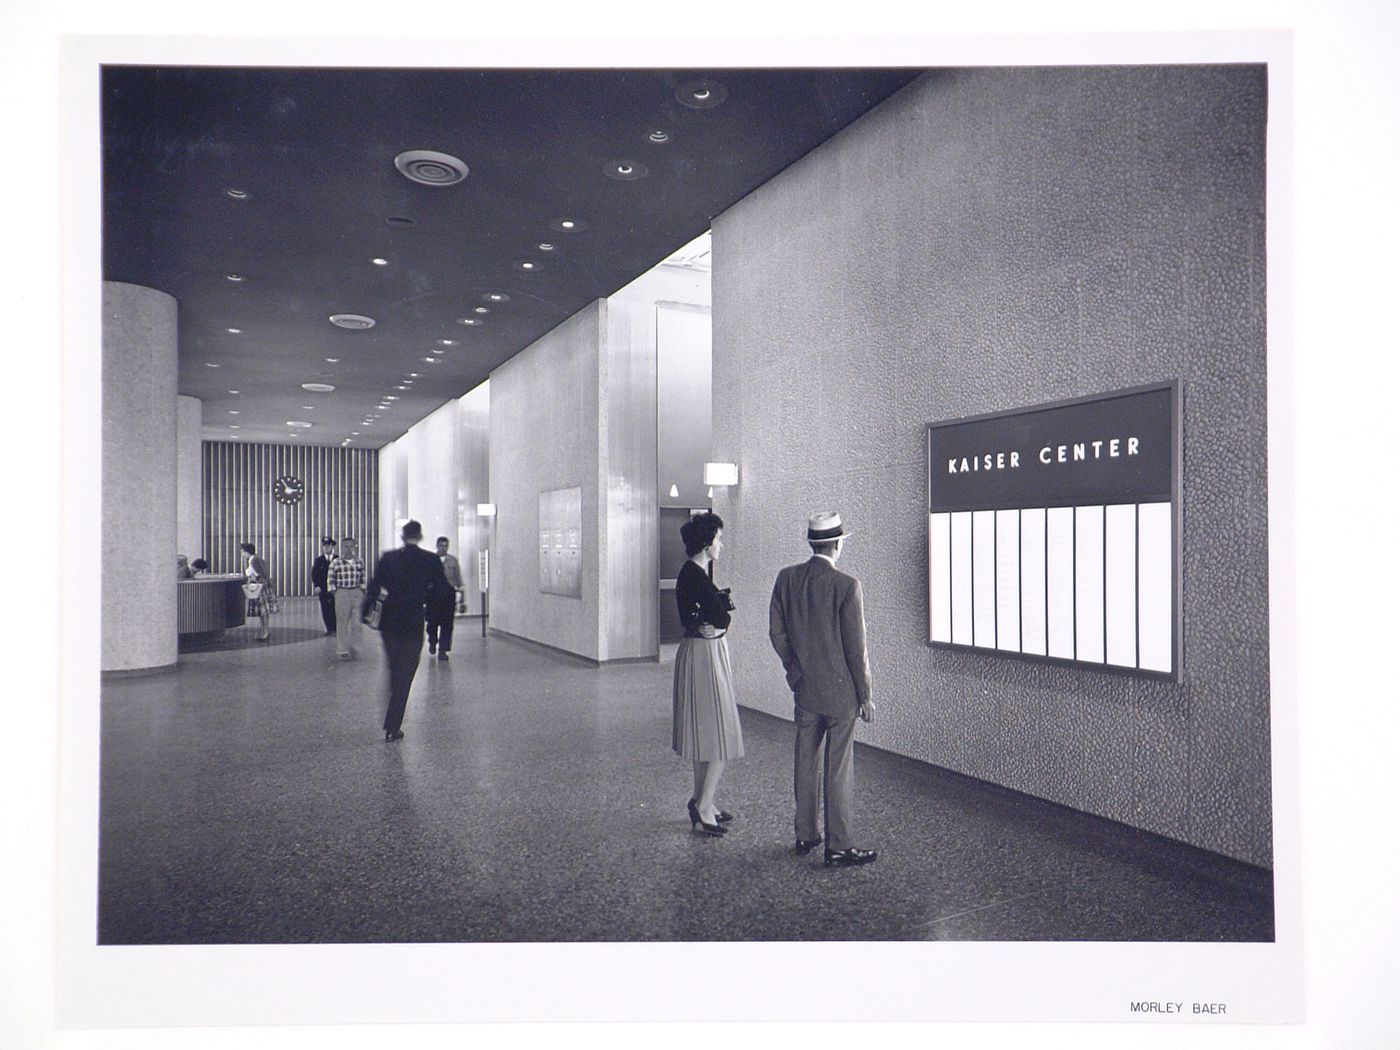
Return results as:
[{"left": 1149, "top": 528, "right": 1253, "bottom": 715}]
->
[{"left": 928, "top": 384, "right": 1177, "bottom": 512}]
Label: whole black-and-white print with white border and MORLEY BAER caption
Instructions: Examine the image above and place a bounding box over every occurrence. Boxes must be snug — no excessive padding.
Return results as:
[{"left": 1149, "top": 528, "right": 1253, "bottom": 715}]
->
[{"left": 5, "top": 4, "right": 1385, "bottom": 1046}]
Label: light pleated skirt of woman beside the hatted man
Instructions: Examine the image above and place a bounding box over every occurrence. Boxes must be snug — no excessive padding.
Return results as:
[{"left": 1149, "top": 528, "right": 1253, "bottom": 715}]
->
[{"left": 671, "top": 637, "right": 743, "bottom": 762}]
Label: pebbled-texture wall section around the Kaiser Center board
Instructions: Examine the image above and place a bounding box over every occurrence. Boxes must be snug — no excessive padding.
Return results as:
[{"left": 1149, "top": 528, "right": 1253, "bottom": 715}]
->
[{"left": 713, "top": 66, "right": 1273, "bottom": 865}]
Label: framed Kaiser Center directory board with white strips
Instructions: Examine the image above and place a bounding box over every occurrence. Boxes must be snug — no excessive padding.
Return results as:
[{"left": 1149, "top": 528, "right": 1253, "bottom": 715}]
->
[{"left": 928, "top": 381, "right": 1182, "bottom": 682}]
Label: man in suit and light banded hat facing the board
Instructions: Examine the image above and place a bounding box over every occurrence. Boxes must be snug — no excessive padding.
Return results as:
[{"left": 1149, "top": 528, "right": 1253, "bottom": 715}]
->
[{"left": 769, "top": 511, "right": 876, "bottom": 868}]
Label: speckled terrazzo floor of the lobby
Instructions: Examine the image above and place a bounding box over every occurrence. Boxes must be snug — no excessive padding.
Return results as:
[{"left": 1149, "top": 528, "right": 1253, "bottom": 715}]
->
[{"left": 98, "top": 599, "right": 1274, "bottom": 945}]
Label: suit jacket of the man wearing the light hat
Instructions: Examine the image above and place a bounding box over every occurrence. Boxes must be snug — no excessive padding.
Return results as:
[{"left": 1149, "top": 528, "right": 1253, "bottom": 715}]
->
[{"left": 769, "top": 554, "right": 871, "bottom": 718}]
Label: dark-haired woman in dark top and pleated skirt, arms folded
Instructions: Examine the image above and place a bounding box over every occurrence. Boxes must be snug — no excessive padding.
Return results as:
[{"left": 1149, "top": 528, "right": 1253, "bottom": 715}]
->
[{"left": 671, "top": 512, "right": 743, "bottom": 836}]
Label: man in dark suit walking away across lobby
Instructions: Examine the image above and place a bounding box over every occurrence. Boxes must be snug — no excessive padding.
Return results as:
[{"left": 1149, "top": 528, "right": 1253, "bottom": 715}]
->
[{"left": 365, "top": 521, "right": 451, "bottom": 743}]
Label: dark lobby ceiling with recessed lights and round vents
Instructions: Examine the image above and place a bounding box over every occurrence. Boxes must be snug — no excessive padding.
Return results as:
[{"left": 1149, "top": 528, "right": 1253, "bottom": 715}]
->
[{"left": 102, "top": 66, "right": 918, "bottom": 448}]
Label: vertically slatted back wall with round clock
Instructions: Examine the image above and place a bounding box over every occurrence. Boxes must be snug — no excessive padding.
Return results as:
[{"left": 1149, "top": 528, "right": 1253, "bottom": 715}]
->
[{"left": 200, "top": 441, "right": 379, "bottom": 596}]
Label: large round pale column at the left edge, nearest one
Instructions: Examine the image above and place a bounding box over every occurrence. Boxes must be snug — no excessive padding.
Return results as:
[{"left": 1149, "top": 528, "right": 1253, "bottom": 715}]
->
[{"left": 102, "top": 281, "right": 179, "bottom": 672}]
